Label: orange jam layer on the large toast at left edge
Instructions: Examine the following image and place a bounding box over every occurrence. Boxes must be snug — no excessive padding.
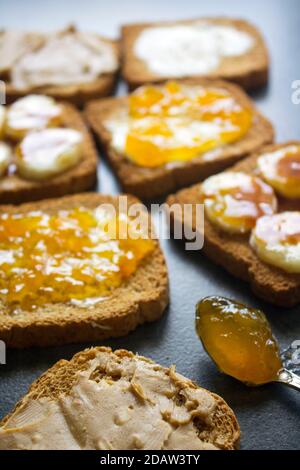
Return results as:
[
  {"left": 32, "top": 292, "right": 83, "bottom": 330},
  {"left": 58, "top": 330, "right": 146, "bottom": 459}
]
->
[{"left": 0, "top": 206, "right": 154, "bottom": 314}]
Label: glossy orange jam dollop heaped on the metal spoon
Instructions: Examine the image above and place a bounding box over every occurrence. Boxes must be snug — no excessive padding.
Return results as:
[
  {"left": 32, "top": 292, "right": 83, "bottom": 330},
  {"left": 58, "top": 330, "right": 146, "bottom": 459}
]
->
[{"left": 196, "top": 296, "right": 282, "bottom": 385}]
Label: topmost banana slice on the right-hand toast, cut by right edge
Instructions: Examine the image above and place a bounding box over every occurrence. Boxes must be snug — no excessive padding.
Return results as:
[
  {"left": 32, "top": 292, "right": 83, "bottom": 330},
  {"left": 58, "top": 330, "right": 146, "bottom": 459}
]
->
[{"left": 257, "top": 144, "right": 300, "bottom": 199}]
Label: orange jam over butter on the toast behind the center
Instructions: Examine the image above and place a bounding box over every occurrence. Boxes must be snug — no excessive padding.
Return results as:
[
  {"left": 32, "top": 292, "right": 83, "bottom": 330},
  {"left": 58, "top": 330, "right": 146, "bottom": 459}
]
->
[{"left": 125, "top": 82, "right": 252, "bottom": 167}]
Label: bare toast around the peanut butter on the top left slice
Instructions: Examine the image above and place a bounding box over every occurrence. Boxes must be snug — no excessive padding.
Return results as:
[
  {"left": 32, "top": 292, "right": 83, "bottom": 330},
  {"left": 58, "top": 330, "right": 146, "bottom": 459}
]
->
[{"left": 0, "top": 25, "right": 120, "bottom": 107}]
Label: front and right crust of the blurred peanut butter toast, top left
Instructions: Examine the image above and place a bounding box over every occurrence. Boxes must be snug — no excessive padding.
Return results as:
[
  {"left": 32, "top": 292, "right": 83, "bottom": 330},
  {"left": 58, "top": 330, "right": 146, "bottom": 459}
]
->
[{"left": 5, "top": 37, "right": 120, "bottom": 107}]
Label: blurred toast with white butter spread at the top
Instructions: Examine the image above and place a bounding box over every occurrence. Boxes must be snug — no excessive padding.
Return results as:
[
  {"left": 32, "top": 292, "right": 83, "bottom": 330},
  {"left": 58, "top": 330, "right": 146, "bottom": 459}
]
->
[{"left": 121, "top": 17, "right": 269, "bottom": 89}]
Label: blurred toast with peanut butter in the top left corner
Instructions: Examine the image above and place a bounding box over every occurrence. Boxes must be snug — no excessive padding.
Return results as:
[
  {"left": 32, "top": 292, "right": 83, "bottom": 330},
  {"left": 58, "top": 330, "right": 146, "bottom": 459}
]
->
[{"left": 0, "top": 26, "right": 119, "bottom": 106}]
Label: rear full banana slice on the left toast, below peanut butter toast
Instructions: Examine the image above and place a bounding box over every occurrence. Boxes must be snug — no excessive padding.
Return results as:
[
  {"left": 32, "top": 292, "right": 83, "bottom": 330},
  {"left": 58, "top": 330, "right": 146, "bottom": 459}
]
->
[{"left": 5, "top": 95, "right": 62, "bottom": 140}]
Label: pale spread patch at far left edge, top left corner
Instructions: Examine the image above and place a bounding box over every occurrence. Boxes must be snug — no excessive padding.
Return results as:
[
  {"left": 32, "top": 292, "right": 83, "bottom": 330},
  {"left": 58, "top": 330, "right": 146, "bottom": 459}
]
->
[{"left": 0, "top": 30, "right": 45, "bottom": 73}]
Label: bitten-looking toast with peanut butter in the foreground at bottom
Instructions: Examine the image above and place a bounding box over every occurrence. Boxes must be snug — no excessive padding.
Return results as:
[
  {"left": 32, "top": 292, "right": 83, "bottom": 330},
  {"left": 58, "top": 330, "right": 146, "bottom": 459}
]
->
[{"left": 0, "top": 347, "right": 240, "bottom": 450}]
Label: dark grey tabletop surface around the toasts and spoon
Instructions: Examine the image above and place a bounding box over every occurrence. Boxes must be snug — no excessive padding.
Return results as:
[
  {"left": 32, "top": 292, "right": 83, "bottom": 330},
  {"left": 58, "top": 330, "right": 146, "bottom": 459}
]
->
[{"left": 0, "top": 0, "right": 300, "bottom": 449}]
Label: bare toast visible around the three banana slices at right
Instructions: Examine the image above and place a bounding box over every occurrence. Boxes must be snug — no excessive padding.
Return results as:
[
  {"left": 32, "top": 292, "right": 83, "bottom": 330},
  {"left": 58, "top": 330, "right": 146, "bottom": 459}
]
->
[{"left": 167, "top": 142, "right": 300, "bottom": 307}]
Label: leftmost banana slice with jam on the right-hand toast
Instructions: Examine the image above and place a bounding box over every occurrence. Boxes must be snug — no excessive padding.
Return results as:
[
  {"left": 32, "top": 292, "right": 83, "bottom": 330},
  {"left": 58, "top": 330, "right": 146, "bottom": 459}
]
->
[{"left": 201, "top": 171, "right": 277, "bottom": 233}]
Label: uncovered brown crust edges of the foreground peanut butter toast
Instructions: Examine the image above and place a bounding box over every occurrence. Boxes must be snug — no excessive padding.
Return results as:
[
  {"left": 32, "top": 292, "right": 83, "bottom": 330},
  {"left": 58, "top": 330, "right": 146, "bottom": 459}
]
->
[{"left": 0, "top": 346, "right": 240, "bottom": 450}]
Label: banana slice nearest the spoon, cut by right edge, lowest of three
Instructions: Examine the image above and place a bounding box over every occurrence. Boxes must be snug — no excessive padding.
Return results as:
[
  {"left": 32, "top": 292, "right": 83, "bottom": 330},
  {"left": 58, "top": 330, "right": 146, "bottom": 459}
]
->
[{"left": 250, "top": 212, "right": 300, "bottom": 273}]
